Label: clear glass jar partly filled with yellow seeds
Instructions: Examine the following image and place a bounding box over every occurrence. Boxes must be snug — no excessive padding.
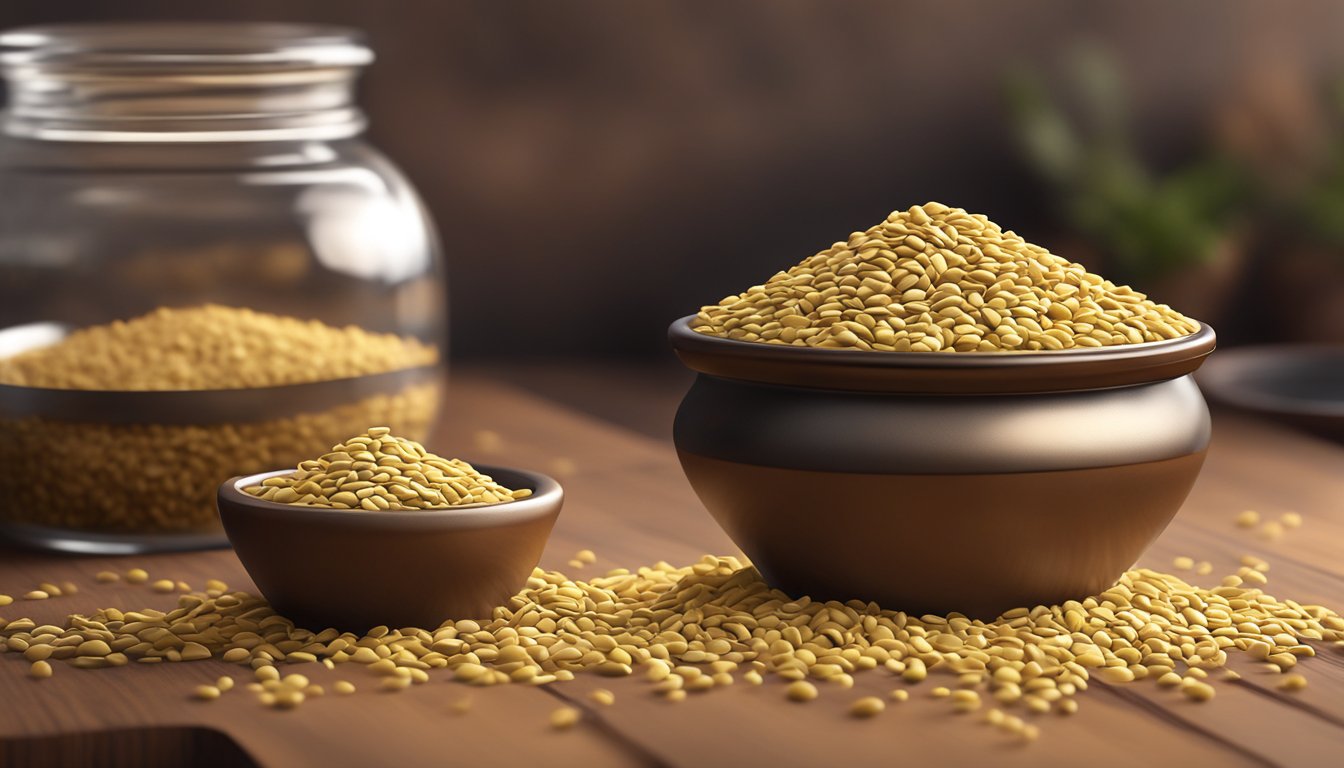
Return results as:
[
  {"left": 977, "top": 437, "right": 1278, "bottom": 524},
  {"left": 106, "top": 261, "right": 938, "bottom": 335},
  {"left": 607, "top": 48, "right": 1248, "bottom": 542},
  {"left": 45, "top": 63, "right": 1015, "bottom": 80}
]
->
[{"left": 0, "top": 24, "right": 446, "bottom": 553}]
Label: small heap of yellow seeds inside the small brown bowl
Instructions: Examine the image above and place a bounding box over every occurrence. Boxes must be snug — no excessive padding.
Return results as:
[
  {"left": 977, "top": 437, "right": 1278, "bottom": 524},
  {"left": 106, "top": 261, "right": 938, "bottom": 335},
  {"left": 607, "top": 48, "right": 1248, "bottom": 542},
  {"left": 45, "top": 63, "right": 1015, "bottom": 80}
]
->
[{"left": 243, "top": 426, "right": 532, "bottom": 512}]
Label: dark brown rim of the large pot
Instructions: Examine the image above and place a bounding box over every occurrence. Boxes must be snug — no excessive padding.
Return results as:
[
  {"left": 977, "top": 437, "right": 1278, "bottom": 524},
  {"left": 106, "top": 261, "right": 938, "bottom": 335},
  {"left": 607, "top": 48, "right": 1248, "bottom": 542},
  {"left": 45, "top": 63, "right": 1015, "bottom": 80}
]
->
[{"left": 668, "top": 315, "right": 1218, "bottom": 394}]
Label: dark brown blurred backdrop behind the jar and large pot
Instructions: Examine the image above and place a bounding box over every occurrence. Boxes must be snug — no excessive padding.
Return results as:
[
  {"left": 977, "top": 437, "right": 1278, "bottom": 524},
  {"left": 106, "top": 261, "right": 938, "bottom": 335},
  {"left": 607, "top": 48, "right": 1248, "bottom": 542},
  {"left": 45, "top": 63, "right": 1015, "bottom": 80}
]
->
[{"left": 0, "top": 0, "right": 1344, "bottom": 359}]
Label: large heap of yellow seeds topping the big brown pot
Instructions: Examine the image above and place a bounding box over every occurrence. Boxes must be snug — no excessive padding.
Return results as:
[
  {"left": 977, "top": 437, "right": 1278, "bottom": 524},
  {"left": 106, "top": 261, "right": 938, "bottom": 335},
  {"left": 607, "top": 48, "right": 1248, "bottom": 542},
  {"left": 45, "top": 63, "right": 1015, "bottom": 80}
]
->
[{"left": 691, "top": 203, "right": 1199, "bottom": 352}]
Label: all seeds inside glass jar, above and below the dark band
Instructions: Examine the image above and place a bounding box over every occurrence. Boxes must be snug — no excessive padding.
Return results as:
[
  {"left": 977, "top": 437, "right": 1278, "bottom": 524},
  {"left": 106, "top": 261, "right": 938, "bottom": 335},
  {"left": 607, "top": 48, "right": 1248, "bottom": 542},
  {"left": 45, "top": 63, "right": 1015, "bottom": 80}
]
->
[{"left": 0, "top": 305, "right": 439, "bottom": 533}]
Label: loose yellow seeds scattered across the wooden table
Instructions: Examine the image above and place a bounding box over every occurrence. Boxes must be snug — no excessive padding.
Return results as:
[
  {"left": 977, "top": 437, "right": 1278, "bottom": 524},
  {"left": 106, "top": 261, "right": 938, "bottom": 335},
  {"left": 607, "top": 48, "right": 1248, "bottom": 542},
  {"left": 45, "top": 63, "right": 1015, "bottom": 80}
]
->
[{"left": 0, "top": 555, "right": 1344, "bottom": 738}]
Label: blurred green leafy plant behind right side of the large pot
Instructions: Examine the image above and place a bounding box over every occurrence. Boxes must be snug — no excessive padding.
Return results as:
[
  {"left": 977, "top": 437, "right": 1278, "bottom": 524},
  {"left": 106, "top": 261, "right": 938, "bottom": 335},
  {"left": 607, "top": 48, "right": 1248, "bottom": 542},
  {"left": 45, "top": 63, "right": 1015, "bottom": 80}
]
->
[{"left": 1007, "top": 50, "right": 1250, "bottom": 324}]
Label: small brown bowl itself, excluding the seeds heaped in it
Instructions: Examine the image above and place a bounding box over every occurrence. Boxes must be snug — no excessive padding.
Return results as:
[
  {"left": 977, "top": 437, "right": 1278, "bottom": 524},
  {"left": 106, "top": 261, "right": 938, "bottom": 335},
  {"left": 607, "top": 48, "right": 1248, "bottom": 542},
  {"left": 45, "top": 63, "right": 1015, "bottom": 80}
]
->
[{"left": 219, "top": 465, "right": 564, "bottom": 632}]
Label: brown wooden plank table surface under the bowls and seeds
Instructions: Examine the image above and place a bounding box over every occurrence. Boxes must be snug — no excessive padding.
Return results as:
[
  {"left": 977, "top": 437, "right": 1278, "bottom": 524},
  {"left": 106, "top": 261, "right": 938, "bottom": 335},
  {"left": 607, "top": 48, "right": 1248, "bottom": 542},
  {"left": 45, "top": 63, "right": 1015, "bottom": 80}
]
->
[{"left": 0, "top": 368, "right": 1344, "bottom": 767}]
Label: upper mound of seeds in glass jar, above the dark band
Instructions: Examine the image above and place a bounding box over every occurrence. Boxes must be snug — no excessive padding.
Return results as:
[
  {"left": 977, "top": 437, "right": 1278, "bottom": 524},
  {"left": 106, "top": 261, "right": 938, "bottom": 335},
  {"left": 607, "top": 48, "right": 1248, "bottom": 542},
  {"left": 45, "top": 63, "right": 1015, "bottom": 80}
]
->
[{"left": 0, "top": 304, "right": 438, "bottom": 391}]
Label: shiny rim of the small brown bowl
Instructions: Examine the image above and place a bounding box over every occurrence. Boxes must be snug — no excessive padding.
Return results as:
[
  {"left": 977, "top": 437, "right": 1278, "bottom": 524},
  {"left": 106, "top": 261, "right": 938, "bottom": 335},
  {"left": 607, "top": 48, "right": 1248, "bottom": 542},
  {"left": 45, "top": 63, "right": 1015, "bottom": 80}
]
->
[{"left": 219, "top": 464, "right": 564, "bottom": 530}]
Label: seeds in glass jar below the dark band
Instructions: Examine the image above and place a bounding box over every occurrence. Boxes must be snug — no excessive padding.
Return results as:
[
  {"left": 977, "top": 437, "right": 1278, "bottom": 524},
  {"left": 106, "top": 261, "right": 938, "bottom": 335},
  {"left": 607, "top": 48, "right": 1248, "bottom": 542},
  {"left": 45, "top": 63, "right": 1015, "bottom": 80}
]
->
[{"left": 0, "top": 382, "right": 439, "bottom": 533}]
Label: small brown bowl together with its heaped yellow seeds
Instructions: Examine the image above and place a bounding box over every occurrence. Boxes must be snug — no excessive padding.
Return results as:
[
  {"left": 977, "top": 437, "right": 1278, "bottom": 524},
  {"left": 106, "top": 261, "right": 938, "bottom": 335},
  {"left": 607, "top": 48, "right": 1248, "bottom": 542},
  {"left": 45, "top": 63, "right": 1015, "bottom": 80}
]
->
[{"left": 219, "top": 428, "right": 563, "bottom": 631}]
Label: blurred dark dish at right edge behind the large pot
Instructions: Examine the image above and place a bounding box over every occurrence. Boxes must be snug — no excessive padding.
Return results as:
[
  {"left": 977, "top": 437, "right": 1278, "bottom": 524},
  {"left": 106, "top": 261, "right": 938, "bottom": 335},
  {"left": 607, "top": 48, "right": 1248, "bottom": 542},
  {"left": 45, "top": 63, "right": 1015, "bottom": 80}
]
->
[{"left": 1199, "top": 344, "right": 1344, "bottom": 441}]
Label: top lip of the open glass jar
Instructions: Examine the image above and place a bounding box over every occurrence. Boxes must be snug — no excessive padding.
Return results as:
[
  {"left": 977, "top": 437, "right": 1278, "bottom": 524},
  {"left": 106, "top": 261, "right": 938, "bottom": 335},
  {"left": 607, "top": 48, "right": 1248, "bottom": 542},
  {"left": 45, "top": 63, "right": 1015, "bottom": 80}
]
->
[{"left": 0, "top": 22, "right": 374, "bottom": 67}]
